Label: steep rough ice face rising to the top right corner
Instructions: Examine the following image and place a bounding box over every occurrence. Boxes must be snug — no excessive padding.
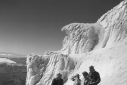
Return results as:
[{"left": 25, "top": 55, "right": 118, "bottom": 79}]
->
[{"left": 97, "top": 0, "right": 127, "bottom": 47}]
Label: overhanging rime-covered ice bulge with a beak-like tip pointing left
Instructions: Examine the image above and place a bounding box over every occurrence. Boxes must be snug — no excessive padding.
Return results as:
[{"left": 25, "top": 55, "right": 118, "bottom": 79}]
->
[{"left": 62, "top": 23, "right": 104, "bottom": 54}]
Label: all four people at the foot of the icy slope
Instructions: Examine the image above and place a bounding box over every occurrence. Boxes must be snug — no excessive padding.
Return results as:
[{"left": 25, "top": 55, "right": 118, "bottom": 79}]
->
[{"left": 51, "top": 66, "right": 101, "bottom": 85}]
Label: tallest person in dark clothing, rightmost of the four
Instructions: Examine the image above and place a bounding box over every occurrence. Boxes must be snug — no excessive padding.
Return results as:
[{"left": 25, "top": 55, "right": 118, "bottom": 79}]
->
[{"left": 89, "top": 66, "right": 101, "bottom": 85}]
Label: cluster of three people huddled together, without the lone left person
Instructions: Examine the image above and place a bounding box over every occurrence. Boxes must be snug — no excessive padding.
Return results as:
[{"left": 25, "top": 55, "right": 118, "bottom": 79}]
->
[{"left": 72, "top": 66, "right": 101, "bottom": 85}]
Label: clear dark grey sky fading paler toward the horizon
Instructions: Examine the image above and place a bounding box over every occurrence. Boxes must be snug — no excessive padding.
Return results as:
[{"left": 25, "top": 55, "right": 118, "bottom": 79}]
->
[{"left": 0, "top": 0, "right": 120, "bottom": 55}]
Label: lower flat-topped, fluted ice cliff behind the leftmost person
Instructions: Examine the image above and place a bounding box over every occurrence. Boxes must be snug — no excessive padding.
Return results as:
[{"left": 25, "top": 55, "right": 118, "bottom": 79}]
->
[{"left": 26, "top": 52, "right": 75, "bottom": 85}]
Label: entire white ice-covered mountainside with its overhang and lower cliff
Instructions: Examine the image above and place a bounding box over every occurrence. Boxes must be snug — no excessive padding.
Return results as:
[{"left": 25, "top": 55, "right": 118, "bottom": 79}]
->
[{"left": 26, "top": 0, "right": 127, "bottom": 85}]
